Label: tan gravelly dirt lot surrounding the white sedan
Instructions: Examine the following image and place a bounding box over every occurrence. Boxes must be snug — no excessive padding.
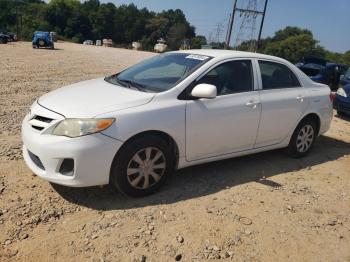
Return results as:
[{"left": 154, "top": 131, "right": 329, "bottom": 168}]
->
[{"left": 0, "top": 42, "right": 350, "bottom": 261}]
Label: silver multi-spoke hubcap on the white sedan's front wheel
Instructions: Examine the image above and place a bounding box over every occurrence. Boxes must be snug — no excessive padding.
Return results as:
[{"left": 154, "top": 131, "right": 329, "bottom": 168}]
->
[{"left": 127, "top": 147, "right": 166, "bottom": 189}]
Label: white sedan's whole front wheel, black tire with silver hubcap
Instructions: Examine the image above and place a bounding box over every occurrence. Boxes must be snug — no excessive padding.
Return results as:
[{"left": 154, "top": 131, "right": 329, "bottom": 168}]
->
[{"left": 110, "top": 135, "right": 174, "bottom": 197}]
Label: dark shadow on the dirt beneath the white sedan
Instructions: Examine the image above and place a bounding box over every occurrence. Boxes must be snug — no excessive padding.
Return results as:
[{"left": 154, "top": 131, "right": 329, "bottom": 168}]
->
[{"left": 52, "top": 136, "right": 350, "bottom": 210}]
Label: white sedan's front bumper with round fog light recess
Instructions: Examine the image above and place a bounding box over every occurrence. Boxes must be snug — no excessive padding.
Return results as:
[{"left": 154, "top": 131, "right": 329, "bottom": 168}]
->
[{"left": 22, "top": 109, "right": 122, "bottom": 187}]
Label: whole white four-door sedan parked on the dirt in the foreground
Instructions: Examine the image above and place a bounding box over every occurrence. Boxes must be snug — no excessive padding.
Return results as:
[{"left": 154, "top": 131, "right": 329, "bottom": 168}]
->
[{"left": 22, "top": 50, "right": 332, "bottom": 196}]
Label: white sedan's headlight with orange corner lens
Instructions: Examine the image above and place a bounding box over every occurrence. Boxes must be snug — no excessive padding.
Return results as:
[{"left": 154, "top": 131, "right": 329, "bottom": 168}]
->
[{"left": 52, "top": 118, "right": 114, "bottom": 137}]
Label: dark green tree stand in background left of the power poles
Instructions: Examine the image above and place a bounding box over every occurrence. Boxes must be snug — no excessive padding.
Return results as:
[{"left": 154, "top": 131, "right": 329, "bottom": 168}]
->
[{"left": 0, "top": 0, "right": 203, "bottom": 50}]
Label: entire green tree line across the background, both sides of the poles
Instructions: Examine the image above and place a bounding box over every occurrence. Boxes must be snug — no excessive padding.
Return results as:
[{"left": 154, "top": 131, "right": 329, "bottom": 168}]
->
[{"left": 0, "top": 0, "right": 350, "bottom": 65}]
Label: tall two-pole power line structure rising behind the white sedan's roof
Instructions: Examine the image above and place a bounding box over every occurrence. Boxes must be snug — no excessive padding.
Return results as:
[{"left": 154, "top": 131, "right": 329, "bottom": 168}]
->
[{"left": 226, "top": 0, "right": 268, "bottom": 52}]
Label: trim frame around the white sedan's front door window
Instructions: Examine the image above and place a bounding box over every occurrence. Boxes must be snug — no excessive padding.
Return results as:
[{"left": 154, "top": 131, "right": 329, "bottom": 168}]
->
[{"left": 177, "top": 57, "right": 259, "bottom": 100}]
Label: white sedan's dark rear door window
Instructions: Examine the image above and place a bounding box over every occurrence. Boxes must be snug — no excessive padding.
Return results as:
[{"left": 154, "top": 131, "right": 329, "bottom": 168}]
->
[{"left": 259, "top": 61, "right": 301, "bottom": 90}]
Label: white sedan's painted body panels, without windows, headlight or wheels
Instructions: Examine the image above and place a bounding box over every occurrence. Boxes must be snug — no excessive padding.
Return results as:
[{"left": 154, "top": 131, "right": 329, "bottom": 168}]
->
[{"left": 22, "top": 50, "right": 333, "bottom": 186}]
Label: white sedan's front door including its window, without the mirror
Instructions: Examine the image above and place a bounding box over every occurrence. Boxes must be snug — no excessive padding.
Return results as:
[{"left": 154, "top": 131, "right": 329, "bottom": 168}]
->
[{"left": 186, "top": 60, "right": 261, "bottom": 161}]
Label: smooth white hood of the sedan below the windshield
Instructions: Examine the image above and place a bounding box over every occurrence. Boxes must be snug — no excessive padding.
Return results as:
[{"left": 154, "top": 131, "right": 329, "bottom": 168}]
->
[{"left": 38, "top": 78, "right": 154, "bottom": 118}]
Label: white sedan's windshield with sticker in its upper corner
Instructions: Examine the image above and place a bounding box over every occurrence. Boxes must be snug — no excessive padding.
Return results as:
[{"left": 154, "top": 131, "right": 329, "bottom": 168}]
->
[{"left": 105, "top": 53, "right": 211, "bottom": 92}]
